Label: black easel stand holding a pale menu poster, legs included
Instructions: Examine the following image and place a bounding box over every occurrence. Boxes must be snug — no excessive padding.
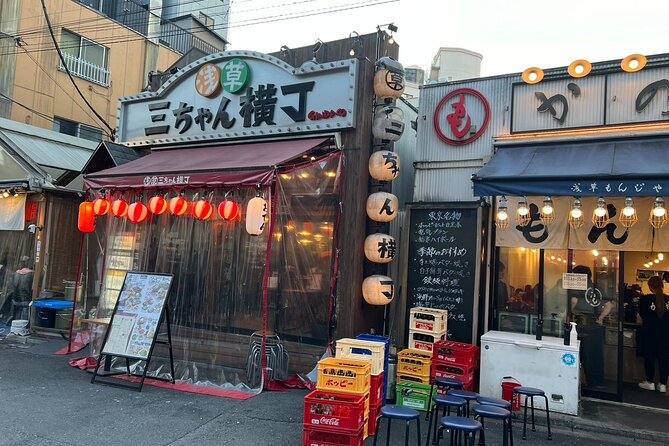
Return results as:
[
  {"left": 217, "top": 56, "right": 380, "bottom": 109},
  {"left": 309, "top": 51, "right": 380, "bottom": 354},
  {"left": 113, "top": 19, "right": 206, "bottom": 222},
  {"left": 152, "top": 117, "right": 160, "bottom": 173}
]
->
[{"left": 91, "top": 271, "right": 174, "bottom": 392}]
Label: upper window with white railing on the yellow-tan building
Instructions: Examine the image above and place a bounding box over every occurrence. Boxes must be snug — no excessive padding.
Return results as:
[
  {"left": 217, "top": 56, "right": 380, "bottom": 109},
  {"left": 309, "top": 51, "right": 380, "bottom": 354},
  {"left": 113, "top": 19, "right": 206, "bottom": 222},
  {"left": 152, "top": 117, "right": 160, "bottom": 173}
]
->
[{"left": 60, "top": 29, "right": 111, "bottom": 87}]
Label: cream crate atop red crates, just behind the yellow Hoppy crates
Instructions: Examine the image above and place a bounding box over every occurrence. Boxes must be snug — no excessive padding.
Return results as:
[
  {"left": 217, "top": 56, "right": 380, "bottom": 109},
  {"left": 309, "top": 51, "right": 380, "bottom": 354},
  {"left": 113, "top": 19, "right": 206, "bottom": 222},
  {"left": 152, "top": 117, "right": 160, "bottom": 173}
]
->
[{"left": 335, "top": 338, "right": 387, "bottom": 435}]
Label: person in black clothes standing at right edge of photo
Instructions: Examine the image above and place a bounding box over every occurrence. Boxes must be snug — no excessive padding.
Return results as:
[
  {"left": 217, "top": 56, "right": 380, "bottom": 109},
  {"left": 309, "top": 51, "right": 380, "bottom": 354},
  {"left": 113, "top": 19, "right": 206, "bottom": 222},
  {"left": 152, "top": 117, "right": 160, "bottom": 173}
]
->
[{"left": 639, "top": 276, "right": 669, "bottom": 393}]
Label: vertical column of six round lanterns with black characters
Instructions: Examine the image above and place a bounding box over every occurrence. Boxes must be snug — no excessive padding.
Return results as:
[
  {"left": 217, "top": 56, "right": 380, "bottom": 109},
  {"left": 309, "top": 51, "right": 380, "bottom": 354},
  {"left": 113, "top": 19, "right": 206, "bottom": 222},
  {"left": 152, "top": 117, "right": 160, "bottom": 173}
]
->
[{"left": 362, "top": 57, "right": 404, "bottom": 305}]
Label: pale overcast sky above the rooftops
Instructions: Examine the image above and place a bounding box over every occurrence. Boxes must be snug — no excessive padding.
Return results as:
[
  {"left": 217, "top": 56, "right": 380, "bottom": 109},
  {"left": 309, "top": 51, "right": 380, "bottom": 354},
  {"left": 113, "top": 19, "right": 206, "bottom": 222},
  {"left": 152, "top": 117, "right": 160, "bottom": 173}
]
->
[{"left": 228, "top": 0, "right": 669, "bottom": 76}]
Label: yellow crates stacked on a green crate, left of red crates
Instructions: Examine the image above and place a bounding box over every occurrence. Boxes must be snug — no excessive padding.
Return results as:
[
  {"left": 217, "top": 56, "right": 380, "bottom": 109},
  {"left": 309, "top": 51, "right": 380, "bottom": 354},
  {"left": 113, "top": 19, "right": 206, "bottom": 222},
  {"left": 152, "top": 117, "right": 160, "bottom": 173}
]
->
[{"left": 396, "top": 348, "right": 435, "bottom": 410}]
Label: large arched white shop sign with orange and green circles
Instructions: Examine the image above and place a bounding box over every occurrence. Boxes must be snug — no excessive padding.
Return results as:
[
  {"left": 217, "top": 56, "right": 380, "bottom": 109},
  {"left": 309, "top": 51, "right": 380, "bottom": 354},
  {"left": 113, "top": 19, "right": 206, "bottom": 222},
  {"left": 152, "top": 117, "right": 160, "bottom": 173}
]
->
[{"left": 118, "top": 51, "right": 358, "bottom": 146}]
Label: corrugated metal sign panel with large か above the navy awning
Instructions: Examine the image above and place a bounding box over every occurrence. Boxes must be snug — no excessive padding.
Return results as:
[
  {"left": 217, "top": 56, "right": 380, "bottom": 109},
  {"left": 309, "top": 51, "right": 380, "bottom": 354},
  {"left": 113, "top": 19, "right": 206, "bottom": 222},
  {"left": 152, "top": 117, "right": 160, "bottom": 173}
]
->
[{"left": 511, "top": 68, "right": 669, "bottom": 133}]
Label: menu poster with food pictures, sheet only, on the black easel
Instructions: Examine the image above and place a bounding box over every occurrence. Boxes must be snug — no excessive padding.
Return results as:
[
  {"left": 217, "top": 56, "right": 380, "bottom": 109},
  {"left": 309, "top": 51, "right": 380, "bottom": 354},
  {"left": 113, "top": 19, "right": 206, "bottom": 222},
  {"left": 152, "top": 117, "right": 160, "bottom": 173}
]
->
[{"left": 102, "top": 272, "right": 172, "bottom": 360}]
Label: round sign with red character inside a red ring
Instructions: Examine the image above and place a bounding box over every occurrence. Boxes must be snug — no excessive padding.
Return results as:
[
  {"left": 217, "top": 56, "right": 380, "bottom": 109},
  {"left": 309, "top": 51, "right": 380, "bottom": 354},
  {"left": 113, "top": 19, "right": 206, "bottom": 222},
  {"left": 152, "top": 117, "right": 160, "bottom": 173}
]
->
[{"left": 434, "top": 88, "right": 490, "bottom": 146}]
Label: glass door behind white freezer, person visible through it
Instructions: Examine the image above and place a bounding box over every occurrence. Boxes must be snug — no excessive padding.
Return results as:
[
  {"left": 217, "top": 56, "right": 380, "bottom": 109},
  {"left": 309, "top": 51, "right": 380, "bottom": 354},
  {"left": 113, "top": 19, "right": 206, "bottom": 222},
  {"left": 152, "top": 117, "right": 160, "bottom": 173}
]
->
[{"left": 568, "top": 250, "right": 622, "bottom": 401}]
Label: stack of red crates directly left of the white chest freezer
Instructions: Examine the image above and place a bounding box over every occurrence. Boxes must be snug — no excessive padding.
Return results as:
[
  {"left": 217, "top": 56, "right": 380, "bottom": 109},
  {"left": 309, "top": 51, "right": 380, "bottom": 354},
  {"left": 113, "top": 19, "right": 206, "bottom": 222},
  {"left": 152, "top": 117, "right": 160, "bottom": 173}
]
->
[{"left": 431, "top": 341, "right": 479, "bottom": 390}]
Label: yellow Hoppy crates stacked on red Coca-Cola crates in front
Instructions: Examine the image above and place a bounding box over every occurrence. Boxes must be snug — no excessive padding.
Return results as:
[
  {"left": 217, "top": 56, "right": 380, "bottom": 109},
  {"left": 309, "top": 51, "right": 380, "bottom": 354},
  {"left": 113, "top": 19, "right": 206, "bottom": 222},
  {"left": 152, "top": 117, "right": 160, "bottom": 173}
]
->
[{"left": 302, "top": 358, "right": 371, "bottom": 446}]
